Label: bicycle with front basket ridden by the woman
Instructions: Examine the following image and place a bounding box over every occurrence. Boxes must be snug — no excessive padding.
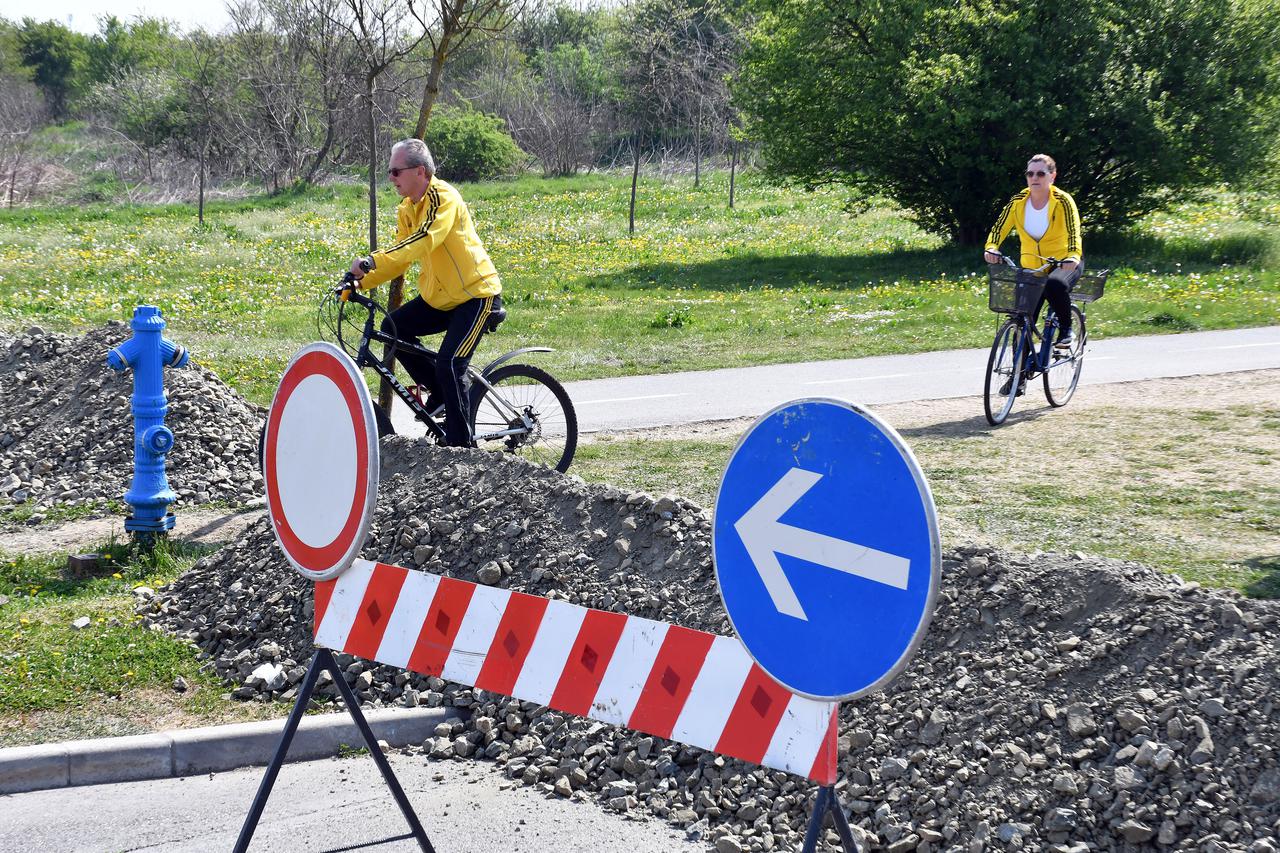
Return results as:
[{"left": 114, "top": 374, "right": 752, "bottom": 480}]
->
[{"left": 983, "top": 255, "right": 1111, "bottom": 427}]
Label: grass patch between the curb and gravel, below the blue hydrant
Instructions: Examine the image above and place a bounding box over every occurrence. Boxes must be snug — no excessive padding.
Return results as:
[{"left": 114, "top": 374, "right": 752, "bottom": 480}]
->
[{"left": 0, "top": 543, "right": 280, "bottom": 745}]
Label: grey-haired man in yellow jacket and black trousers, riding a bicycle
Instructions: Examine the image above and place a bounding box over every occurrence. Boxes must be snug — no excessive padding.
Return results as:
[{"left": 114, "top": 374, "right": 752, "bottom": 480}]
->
[{"left": 351, "top": 140, "right": 502, "bottom": 447}]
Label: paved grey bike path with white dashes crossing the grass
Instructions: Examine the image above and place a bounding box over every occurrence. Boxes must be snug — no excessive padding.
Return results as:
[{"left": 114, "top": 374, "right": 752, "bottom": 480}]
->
[{"left": 392, "top": 325, "right": 1280, "bottom": 434}]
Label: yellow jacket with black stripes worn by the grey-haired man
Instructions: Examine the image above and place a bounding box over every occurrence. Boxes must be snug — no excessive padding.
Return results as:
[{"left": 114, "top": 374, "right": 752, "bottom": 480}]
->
[{"left": 360, "top": 178, "right": 502, "bottom": 311}]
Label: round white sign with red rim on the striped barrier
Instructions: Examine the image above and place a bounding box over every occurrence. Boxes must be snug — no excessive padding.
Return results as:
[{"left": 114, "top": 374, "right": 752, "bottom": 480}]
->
[{"left": 262, "top": 342, "right": 379, "bottom": 580}]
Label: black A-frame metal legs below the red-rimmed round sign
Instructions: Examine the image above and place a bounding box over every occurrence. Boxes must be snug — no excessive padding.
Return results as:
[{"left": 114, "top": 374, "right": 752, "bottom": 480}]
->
[{"left": 234, "top": 648, "right": 435, "bottom": 853}]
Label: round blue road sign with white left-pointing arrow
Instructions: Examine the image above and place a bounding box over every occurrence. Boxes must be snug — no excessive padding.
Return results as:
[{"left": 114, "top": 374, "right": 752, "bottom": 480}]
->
[{"left": 712, "top": 398, "right": 941, "bottom": 699}]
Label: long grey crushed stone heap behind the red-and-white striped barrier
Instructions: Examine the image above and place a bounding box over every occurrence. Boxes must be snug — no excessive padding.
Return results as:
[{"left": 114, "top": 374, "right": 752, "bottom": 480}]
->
[{"left": 138, "top": 437, "right": 1280, "bottom": 853}]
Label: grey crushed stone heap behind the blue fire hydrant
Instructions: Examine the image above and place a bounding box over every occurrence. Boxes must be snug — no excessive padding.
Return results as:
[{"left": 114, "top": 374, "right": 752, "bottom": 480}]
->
[{"left": 0, "top": 323, "right": 264, "bottom": 521}]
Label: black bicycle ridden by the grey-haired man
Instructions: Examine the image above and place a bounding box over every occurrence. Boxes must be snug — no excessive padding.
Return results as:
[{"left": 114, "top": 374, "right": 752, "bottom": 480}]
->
[{"left": 317, "top": 273, "right": 577, "bottom": 473}]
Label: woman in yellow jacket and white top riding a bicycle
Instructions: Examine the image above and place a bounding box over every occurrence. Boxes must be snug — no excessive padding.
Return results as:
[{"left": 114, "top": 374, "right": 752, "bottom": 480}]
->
[{"left": 983, "top": 154, "right": 1084, "bottom": 347}]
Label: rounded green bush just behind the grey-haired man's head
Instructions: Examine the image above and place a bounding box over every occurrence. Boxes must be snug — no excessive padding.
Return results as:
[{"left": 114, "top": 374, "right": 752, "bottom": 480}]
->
[{"left": 426, "top": 106, "right": 526, "bottom": 181}]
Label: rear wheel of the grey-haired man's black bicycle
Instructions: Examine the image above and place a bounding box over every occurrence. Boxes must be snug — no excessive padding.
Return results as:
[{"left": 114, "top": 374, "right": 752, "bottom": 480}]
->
[{"left": 471, "top": 364, "right": 577, "bottom": 473}]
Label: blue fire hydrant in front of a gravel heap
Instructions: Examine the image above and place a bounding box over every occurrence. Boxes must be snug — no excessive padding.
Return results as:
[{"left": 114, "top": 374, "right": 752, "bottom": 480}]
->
[{"left": 106, "top": 305, "right": 191, "bottom": 546}]
